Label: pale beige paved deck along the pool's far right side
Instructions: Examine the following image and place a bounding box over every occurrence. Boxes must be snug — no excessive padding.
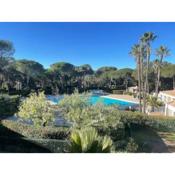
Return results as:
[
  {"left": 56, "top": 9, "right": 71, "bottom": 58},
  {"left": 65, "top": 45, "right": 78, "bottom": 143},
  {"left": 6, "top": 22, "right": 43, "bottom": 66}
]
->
[{"left": 103, "top": 94, "right": 139, "bottom": 104}]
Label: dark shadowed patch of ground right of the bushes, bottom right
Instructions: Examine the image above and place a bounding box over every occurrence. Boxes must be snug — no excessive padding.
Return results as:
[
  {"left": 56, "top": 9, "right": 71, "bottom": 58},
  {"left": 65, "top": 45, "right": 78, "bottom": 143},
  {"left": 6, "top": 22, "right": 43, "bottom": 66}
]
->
[{"left": 131, "top": 125, "right": 170, "bottom": 153}]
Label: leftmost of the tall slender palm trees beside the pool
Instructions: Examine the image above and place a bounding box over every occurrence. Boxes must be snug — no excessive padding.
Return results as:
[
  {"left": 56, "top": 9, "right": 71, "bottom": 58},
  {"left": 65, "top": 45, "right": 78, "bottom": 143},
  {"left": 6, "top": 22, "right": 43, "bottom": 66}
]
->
[{"left": 130, "top": 44, "right": 142, "bottom": 112}]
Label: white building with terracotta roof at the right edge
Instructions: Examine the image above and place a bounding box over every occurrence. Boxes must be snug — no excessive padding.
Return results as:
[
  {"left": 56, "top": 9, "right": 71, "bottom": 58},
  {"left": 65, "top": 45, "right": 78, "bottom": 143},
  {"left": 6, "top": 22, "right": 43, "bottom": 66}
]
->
[{"left": 159, "top": 90, "right": 175, "bottom": 116}]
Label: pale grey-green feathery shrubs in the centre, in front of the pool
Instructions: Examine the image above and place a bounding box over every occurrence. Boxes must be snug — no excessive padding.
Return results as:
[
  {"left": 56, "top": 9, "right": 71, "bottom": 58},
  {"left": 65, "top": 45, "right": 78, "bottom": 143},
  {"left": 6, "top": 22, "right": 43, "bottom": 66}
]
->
[{"left": 58, "top": 92, "right": 124, "bottom": 137}]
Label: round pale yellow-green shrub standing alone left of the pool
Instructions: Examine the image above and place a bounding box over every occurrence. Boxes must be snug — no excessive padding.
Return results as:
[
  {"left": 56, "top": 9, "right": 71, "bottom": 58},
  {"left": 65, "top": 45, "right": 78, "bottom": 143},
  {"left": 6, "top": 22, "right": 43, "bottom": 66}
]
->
[{"left": 18, "top": 92, "right": 54, "bottom": 126}]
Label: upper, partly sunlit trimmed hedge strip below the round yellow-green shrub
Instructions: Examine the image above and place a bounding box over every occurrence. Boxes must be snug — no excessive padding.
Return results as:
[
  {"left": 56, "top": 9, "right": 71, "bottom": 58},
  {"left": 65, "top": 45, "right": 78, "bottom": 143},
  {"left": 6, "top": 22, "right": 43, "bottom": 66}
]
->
[{"left": 0, "top": 120, "right": 70, "bottom": 140}]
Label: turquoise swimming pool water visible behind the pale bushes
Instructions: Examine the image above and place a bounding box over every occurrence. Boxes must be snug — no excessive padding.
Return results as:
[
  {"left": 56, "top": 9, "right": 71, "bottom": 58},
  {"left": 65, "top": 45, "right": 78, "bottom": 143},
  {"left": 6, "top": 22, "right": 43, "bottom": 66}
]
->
[{"left": 47, "top": 95, "right": 138, "bottom": 108}]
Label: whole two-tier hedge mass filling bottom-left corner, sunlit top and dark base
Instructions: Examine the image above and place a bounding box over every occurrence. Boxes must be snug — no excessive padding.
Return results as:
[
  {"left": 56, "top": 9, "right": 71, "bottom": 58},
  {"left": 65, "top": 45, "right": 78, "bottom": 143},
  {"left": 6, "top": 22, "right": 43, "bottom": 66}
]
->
[{"left": 0, "top": 120, "right": 70, "bottom": 153}]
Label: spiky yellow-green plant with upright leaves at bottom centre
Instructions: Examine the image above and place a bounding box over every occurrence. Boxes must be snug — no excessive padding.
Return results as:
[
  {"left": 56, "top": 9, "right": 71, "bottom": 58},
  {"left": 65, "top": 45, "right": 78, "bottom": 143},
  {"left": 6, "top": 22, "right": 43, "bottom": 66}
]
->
[{"left": 70, "top": 127, "right": 113, "bottom": 153}]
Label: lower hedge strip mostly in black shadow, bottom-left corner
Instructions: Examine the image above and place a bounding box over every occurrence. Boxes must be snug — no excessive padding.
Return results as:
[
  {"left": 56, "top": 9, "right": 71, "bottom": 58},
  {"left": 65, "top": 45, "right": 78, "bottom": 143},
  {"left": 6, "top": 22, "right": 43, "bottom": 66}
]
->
[{"left": 0, "top": 136, "right": 68, "bottom": 153}]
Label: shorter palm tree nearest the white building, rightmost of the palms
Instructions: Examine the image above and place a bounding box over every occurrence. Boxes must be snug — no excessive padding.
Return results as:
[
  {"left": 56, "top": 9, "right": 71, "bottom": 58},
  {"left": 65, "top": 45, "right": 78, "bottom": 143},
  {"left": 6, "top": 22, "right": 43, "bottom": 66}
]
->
[{"left": 155, "top": 46, "right": 170, "bottom": 97}]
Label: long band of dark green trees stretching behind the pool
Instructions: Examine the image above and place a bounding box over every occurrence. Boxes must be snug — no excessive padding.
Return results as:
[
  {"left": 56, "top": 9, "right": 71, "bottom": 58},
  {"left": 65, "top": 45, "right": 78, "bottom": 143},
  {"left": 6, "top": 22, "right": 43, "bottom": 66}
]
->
[{"left": 0, "top": 37, "right": 175, "bottom": 96}]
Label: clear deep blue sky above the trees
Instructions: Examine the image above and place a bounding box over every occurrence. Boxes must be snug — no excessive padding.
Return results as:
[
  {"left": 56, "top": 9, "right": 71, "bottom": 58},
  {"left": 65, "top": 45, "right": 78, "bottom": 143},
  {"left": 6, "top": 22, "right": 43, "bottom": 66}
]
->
[{"left": 0, "top": 22, "right": 175, "bottom": 69}]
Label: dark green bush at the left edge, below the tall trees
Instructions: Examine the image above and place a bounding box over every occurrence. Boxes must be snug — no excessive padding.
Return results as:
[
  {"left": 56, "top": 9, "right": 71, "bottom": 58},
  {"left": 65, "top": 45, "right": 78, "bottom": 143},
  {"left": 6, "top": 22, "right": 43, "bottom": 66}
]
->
[{"left": 0, "top": 95, "right": 19, "bottom": 116}]
